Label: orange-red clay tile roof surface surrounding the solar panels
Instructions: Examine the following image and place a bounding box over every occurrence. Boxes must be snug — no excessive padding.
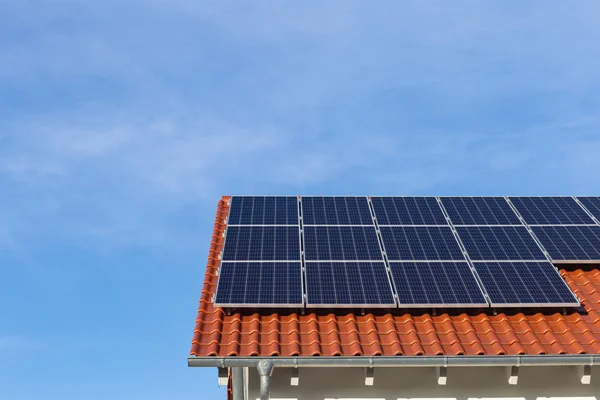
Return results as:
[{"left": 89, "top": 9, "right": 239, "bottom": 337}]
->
[{"left": 190, "top": 197, "right": 600, "bottom": 356}]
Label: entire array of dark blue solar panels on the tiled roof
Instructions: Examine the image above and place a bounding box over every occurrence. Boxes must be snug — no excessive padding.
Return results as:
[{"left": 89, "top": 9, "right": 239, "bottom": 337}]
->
[{"left": 214, "top": 196, "right": 600, "bottom": 308}]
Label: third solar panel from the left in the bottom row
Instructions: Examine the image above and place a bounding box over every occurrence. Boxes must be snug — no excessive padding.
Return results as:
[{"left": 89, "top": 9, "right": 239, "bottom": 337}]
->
[{"left": 390, "top": 262, "right": 488, "bottom": 307}]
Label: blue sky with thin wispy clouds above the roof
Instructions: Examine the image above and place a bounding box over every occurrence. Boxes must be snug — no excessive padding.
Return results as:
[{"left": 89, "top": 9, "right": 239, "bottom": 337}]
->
[{"left": 0, "top": 0, "right": 600, "bottom": 400}]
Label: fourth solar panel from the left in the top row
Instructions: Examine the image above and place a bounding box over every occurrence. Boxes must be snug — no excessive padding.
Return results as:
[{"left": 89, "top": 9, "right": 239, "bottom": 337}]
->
[{"left": 440, "top": 197, "right": 522, "bottom": 225}]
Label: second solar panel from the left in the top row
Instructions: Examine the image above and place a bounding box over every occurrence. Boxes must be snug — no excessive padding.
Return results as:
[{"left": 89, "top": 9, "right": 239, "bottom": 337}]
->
[{"left": 302, "top": 196, "right": 373, "bottom": 225}]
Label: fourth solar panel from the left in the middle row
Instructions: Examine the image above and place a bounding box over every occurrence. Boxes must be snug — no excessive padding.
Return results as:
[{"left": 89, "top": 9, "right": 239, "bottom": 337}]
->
[{"left": 456, "top": 226, "right": 546, "bottom": 261}]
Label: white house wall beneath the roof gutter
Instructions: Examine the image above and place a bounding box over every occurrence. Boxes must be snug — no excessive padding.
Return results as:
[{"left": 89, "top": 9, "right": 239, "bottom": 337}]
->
[{"left": 248, "top": 367, "right": 600, "bottom": 400}]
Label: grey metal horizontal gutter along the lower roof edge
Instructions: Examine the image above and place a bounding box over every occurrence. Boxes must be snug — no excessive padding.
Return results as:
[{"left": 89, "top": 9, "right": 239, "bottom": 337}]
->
[{"left": 188, "top": 354, "right": 600, "bottom": 368}]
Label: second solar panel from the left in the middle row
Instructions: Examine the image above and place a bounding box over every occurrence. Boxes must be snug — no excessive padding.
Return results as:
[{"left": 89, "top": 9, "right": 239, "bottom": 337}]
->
[{"left": 304, "top": 226, "right": 383, "bottom": 261}]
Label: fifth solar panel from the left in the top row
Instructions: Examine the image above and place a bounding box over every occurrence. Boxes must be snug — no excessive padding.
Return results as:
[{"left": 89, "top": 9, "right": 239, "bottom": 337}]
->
[{"left": 510, "top": 197, "right": 595, "bottom": 225}]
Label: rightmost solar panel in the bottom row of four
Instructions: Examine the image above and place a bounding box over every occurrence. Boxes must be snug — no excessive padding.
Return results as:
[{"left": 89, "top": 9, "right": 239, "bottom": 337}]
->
[{"left": 473, "top": 262, "right": 579, "bottom": 307}]
